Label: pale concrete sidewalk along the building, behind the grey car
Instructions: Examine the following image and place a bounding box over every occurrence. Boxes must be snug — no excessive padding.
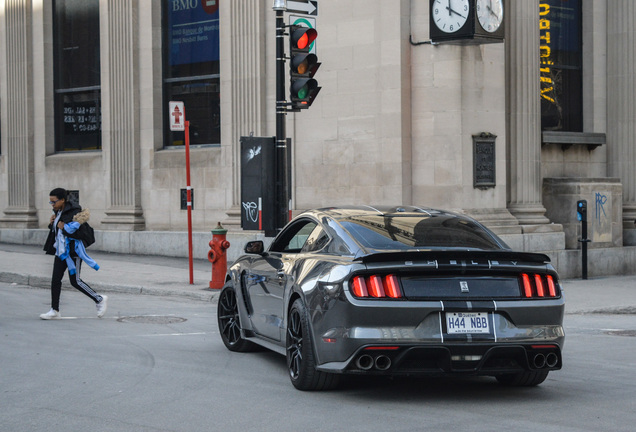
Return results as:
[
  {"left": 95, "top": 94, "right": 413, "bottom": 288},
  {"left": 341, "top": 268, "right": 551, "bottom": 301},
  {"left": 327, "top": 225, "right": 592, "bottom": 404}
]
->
[{"left": 0, "top": 243, "right": 636, "bottom": 314}]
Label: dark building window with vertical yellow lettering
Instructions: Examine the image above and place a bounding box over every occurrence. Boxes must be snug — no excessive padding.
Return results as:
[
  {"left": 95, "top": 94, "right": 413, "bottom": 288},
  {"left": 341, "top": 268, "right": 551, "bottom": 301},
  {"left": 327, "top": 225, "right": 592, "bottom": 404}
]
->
[{"left": 539, "top": 0, "right": 583, "bottom": 132}]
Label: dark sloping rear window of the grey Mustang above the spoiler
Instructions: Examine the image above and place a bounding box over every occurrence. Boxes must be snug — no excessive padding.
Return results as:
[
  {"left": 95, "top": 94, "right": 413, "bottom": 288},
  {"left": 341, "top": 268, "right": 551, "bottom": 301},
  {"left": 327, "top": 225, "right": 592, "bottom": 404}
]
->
[{"left": 340, "top": 215, "right": 502, "bottom": 250}]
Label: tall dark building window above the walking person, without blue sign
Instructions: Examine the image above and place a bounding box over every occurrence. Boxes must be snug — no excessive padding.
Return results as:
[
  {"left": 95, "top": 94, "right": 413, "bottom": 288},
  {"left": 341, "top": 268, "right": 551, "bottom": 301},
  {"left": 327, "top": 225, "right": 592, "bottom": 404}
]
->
[{"left": 53, "top": 0, "right": 102, "bottom": 151}]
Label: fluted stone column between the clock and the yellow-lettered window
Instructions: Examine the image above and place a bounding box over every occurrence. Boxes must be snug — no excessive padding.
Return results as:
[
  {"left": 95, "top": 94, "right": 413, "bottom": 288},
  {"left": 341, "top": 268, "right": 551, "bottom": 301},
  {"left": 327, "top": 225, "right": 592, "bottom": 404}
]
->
[{"left": 505, "top": 0, "right": 549, "bottom": 225}]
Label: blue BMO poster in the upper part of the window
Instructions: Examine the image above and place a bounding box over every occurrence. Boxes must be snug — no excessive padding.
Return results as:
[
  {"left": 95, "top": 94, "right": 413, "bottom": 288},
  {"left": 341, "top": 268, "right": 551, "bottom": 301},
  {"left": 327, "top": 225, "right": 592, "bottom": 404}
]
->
[{"left": 165, "top": 0, "right": 219, "bottom": 66}]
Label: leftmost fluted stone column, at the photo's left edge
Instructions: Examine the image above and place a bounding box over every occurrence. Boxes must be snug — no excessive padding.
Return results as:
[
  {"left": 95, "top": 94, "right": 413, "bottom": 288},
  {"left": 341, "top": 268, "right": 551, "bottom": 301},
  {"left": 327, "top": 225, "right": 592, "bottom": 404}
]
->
[{"left": 0, "top": 0, "right": 37, "bottom": 228}]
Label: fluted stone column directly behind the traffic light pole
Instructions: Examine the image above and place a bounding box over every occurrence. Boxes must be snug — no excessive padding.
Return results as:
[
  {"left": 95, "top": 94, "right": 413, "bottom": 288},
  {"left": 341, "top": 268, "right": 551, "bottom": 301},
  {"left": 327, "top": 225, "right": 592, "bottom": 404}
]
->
[{"left": 219, "top": 0, "right": 266, "bottom": 229}]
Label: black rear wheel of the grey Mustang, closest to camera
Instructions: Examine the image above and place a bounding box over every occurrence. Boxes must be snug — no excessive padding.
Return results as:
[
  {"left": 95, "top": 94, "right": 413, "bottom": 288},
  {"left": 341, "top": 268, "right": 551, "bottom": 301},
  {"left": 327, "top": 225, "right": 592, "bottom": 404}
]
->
[{"left": 286, "top": 299, "right": 340, "bottom": 390}]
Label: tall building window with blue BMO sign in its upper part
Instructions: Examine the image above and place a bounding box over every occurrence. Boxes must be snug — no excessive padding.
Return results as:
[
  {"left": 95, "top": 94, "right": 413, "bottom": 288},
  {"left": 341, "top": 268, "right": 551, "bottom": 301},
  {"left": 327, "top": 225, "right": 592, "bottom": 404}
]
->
[{"left": 162, "top": 0, "right": 221, "bottom": 147}]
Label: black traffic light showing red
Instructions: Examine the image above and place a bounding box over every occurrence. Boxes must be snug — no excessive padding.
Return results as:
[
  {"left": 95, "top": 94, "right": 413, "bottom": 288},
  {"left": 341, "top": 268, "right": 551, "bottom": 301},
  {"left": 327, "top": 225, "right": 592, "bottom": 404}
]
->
[{"left": 289, "top": 25, "right": 320, "bottom": 110}]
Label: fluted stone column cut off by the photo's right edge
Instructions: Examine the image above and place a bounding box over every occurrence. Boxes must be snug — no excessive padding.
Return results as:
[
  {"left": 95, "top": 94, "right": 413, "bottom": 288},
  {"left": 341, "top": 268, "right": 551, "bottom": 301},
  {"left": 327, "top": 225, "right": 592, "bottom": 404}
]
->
[{"left": 607, "top": 0, "right": 636, "bottom": 246}]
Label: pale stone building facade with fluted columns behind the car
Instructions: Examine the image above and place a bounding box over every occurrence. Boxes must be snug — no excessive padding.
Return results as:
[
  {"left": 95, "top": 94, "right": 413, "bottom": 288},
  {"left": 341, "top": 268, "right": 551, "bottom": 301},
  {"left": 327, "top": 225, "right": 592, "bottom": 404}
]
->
[{"left": 0, "top": 0, "right": 636, "bottom": 276}]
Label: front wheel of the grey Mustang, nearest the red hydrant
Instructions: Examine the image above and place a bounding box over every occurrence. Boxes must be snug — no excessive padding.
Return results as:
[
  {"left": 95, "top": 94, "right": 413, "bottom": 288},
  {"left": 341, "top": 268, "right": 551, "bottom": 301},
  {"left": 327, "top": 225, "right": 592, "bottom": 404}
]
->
[{"left": 217, "top": 282, "right": 257, "bottom": 352}]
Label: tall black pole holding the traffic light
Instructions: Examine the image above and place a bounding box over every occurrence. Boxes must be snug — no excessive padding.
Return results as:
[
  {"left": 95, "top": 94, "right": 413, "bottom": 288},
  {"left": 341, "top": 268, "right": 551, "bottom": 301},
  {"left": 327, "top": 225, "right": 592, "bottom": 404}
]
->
[{"left": 276, "top": 10, "right": 289, "bottom": 229}]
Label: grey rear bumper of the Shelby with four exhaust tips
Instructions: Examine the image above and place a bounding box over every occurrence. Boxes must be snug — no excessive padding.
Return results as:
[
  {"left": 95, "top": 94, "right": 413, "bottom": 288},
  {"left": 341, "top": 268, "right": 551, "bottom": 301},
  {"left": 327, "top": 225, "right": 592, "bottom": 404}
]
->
[{"left": 314, "top": 299, "right": 565, "bottom": 375}]
